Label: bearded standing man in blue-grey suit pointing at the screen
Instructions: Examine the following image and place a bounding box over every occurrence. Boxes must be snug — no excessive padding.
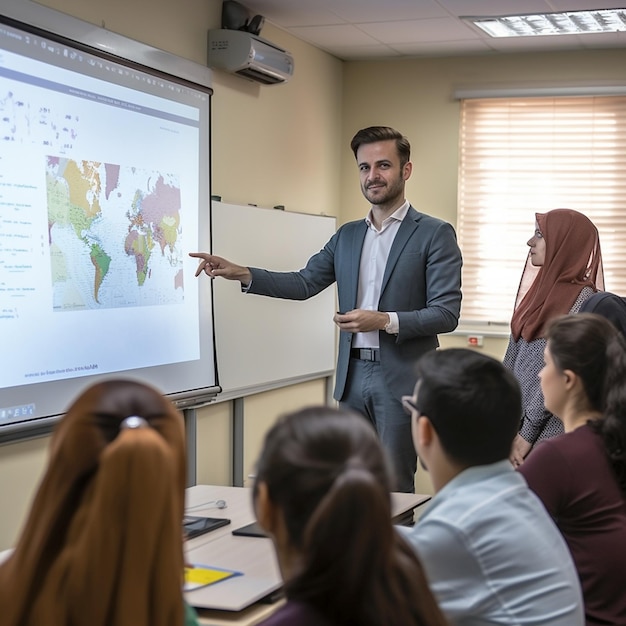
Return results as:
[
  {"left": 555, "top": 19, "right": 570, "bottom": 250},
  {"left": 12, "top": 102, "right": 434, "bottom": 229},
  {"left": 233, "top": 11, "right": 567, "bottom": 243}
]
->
[{"left": 190, "top": 126, "right": 462, "bottom": 493}]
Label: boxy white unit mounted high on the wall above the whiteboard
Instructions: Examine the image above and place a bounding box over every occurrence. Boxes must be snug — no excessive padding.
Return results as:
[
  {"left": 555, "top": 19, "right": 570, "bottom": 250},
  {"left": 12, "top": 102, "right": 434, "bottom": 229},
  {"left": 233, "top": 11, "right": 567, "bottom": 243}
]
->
[{"left": 208, "top": 29, "right": 293, "bottom": 85}]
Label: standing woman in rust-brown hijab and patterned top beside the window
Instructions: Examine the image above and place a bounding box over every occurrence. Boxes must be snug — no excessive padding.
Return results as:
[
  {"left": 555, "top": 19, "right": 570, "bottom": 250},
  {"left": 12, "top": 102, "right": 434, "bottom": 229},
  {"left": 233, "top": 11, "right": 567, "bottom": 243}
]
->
[{"left": 504, "top": 209, "right": 604, "bottom": 467}]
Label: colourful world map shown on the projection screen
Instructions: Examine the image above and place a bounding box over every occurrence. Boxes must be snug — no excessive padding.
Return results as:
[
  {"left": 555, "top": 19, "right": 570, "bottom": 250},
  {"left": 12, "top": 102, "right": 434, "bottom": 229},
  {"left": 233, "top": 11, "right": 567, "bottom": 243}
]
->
[{"left": 46, "top": 156, "right": 184, "bottom": 311}]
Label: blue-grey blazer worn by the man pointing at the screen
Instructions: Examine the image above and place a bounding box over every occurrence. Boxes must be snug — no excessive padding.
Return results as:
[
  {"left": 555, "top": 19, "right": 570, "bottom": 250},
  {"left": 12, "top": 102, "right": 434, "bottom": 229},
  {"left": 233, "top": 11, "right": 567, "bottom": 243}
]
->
[{"left": 249, "top": 207, "right": 462, "bottom": 400}]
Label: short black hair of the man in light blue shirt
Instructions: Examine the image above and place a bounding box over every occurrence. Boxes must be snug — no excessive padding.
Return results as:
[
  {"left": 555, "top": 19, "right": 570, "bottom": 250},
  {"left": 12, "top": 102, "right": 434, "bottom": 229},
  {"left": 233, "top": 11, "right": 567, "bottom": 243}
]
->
[{"left": 416, "top": 348, "right": 522, "bottom": 467}]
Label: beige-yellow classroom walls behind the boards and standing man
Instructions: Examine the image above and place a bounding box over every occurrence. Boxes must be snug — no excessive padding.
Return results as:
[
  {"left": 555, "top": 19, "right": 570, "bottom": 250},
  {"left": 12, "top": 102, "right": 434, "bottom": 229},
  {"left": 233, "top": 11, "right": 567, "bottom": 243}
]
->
[{"left": 0, "top": 0, "right": 626, "bottom": 550}]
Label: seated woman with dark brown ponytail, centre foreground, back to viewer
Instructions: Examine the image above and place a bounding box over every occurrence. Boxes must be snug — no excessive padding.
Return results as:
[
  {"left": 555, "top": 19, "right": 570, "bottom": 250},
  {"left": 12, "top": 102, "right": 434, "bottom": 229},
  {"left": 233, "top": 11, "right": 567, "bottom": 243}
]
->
[{"left": 253, "top": 407, "right": 446, "bottom": 626}]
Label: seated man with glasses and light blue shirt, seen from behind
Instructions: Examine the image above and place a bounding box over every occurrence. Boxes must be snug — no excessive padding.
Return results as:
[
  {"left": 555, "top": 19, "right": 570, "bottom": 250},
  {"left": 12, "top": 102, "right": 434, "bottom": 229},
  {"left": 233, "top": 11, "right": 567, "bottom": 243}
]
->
[{"left": 404, "top": 348, "right": 584, "bottom": 626}]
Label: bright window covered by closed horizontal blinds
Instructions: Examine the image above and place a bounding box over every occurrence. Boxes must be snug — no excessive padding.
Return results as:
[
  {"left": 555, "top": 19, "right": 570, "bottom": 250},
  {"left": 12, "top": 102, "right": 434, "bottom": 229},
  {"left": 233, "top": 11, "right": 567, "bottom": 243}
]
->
[{"left": 457, "top": 96, "right": 626, "bottom": 323}]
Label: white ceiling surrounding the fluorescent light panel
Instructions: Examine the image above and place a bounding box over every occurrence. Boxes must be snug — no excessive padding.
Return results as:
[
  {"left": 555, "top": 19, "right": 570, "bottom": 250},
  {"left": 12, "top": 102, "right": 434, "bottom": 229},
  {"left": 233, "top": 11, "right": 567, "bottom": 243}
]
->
[{"left": 233, "top": 0, "right": 626, "bottom": 61}]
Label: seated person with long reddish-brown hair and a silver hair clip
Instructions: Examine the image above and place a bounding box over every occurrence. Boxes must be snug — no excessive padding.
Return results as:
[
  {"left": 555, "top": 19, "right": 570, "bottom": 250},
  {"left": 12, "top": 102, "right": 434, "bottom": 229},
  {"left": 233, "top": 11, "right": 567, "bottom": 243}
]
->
[{"left": 0, "top": 380, "right": 197, "bottom": 626}]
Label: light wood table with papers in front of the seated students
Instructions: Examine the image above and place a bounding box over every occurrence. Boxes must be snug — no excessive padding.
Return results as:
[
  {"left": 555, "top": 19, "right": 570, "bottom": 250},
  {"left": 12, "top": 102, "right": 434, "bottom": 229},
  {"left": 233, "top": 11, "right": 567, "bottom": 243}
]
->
[{"left": 185, "top": 485, "right": 431, "bottom": 626}]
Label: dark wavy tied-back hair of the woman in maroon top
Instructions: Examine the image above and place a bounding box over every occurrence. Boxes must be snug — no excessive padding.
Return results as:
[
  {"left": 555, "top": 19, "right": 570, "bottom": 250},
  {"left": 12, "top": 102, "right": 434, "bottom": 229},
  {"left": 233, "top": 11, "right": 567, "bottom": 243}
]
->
[{"left": 546, "top": 313, "right": 626, "bottom": 493}]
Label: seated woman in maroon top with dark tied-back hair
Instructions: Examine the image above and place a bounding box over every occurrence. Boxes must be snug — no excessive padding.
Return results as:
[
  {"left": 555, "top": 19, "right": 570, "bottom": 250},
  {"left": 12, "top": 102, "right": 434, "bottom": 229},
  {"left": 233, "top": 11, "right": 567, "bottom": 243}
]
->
[{"left": 520, "top": 313, "right": 626, "bottom": 625}]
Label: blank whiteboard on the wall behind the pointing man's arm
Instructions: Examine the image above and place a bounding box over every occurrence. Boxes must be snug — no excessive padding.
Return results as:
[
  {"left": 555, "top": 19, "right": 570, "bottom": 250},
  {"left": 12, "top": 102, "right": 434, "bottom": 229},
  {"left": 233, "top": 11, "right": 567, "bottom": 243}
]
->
[{"left": 210, "top": 202, "right": 336, "bottom": 399}]
